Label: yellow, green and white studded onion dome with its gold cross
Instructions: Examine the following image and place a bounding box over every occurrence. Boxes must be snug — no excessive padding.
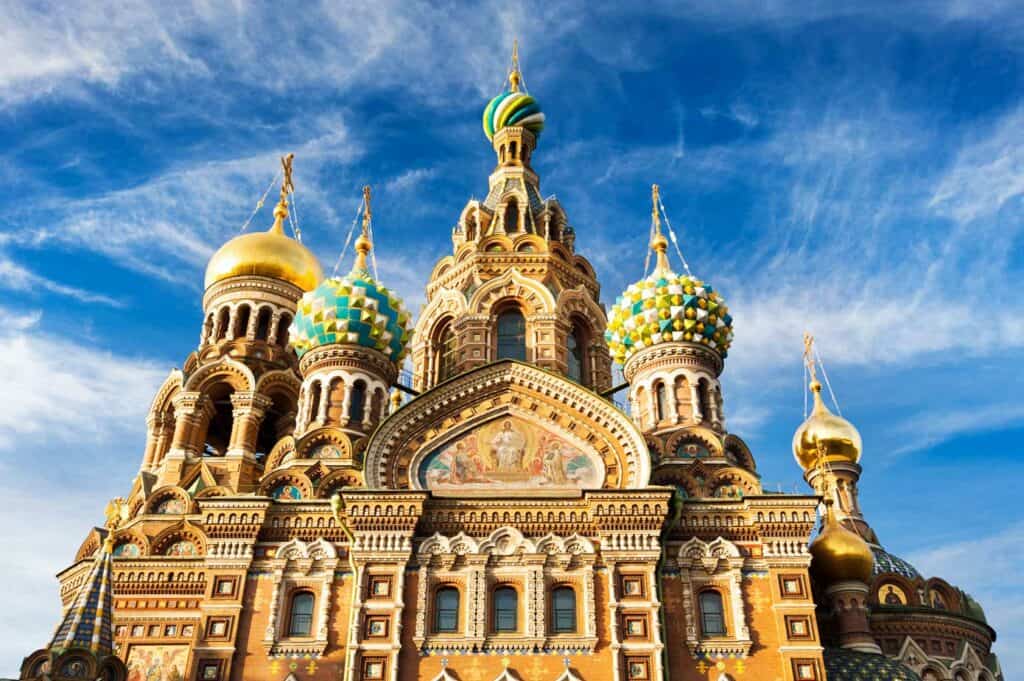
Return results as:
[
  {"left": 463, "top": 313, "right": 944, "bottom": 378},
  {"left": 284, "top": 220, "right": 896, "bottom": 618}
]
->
[{"left": 604, "top": 184, "right": 732, "bottom": 365}]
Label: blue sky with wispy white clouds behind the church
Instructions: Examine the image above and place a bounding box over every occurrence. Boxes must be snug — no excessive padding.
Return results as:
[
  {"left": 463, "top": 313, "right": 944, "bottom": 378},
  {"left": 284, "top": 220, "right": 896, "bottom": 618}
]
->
[{"left": 0, "top": 0, "right": 1024, "bottom": 679}]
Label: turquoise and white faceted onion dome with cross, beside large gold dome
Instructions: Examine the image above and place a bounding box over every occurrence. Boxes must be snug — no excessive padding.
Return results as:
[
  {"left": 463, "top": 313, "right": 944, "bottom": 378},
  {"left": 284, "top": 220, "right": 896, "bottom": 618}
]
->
[{"left": 290, "top": 186, "right": 412, "bottom": 364}]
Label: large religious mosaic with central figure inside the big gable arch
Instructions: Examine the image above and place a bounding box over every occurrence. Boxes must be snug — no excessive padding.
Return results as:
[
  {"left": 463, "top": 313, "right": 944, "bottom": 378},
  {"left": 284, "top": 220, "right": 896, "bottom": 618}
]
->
[{"left": 419, "top": 417, "right": 604, "bottom": 490}]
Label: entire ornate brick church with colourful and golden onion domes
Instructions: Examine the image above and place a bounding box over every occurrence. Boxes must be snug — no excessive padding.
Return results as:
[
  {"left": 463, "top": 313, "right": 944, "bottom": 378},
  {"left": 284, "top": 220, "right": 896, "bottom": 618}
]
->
[{"left": 22, "top": 46, "right": 1002, "bottom": 681}]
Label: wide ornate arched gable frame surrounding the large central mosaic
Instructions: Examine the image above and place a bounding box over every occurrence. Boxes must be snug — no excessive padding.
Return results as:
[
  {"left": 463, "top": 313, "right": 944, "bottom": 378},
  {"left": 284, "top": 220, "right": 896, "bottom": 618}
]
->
[{"left": 365, "top": 360, "right": 650, "bottom": 488}]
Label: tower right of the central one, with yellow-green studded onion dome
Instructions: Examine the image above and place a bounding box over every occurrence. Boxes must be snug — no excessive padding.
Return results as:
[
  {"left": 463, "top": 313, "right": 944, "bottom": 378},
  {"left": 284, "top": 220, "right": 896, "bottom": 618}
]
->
[{"left": 605, "top": 184, "right": 761, "bottom": 497}]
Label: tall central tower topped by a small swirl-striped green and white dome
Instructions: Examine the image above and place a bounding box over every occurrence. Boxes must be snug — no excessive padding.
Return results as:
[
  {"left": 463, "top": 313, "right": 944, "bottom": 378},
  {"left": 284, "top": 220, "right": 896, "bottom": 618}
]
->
[{"left": 412, "top": 42, "right": 611, "bottom": 391}]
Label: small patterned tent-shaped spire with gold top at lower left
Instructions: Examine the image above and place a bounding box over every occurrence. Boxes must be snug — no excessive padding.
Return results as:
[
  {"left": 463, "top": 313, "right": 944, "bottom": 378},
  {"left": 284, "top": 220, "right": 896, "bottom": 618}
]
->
[{"left": 49, "top": 498, "right": 128, "bottom": 657}]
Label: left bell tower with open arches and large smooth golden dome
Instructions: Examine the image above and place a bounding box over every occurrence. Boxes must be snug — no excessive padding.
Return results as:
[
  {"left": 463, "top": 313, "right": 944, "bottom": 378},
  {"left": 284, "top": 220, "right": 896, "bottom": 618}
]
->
[{"left": 140, "top": 155, "right": 322, "bottom": 492}]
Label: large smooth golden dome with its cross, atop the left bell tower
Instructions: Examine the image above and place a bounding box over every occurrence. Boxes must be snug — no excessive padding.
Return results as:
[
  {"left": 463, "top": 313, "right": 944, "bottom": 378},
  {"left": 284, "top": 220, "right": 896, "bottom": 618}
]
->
[{"left": 206, "top": 154, "right": 324, "bottom": 291}]
